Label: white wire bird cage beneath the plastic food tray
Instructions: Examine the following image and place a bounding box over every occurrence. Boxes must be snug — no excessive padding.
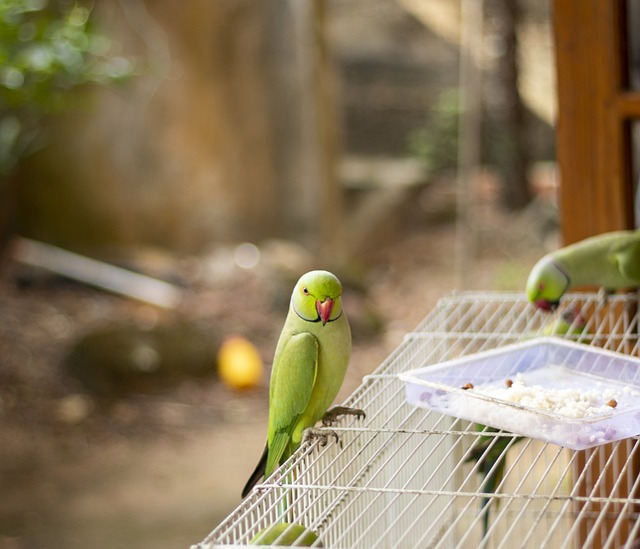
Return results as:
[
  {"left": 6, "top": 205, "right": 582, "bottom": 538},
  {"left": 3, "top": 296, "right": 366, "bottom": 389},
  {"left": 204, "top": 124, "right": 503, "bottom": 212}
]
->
[{"left": 192, "top": 292, "right": 640, "bottom": 549}]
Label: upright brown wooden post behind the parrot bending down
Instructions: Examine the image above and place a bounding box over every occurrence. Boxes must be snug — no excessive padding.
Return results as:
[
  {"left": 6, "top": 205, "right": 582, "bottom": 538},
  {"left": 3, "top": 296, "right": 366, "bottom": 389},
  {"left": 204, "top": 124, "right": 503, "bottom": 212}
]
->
[{"left": 553, "top": 0, "right": 640, "bottom": 244}]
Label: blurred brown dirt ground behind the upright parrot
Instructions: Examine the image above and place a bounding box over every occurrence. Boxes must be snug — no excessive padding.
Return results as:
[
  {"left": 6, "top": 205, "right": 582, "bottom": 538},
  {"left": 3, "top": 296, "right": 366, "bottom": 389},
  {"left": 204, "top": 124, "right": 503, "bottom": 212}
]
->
[{"left": 0, "top": 177, "right": 556, "bottom": 549}]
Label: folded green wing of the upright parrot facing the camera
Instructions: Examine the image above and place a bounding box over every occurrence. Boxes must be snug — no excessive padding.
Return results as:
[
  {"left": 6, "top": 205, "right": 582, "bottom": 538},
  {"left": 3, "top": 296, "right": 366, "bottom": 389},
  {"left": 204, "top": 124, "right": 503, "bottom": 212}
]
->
[{"left": 265, "top": 332, "right": 318, "bottom": 476}]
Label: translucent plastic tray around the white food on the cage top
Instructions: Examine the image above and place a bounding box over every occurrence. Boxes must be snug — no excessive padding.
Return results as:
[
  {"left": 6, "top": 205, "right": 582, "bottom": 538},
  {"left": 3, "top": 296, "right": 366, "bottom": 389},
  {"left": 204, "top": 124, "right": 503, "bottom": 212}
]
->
[{"left": 398, "top": 337, "right": 640, "bottom": 450}]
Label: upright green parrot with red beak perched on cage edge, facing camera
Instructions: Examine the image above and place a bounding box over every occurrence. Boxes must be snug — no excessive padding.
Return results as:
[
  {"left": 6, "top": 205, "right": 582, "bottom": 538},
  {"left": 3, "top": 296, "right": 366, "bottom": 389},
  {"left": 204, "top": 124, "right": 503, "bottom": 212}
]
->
[{"left": 242, "top": 271, "right": 364, "bottom": 497}]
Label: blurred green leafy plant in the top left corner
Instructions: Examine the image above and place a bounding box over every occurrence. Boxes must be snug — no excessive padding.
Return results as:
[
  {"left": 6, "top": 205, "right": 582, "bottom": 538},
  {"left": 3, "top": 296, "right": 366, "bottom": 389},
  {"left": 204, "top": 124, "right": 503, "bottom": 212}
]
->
[{"left": 0, "top": 0, "right": 134, "bottom": 179}]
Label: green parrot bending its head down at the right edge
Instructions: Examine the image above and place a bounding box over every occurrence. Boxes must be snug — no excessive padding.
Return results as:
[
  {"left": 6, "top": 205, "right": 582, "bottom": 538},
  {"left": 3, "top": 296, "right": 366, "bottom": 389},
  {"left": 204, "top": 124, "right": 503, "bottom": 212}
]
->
[{"left": 527, "top": 231, "right": 640, "bottom": 311}]
